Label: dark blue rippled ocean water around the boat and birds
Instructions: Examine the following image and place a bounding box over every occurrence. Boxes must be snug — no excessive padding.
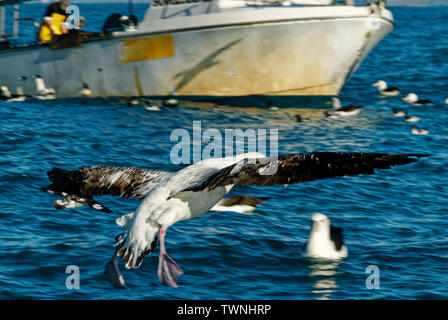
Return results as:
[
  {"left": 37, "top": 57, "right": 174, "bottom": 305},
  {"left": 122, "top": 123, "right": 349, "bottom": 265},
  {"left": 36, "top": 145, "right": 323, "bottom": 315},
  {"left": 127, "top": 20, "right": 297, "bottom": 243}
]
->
[{"left": 0, "top": 4, "right": 448, "bottom": 299}]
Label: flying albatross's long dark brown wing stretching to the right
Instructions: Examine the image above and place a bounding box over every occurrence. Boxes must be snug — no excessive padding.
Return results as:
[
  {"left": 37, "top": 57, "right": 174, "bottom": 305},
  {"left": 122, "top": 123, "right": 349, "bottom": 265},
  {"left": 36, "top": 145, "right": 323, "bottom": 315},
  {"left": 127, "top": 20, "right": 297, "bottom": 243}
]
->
[{"left": 178, "top": 152, "right": 427, "bottom": 191}]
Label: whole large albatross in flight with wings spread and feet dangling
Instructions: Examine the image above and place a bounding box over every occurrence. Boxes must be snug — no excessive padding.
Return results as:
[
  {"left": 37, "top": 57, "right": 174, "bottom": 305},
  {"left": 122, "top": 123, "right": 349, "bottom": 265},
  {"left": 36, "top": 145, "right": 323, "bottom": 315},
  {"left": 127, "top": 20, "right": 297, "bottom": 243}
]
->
[{"left": 43, "top": 152, "right": 426, "bottom": 288}]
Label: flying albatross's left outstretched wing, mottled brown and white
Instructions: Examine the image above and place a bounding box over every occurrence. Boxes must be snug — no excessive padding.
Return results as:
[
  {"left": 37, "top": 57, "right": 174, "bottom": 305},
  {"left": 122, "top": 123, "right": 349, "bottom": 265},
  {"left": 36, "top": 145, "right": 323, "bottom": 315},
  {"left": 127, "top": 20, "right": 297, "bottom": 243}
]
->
[{"left": 42, "top": 166, "right": 172, "bottom": 212}]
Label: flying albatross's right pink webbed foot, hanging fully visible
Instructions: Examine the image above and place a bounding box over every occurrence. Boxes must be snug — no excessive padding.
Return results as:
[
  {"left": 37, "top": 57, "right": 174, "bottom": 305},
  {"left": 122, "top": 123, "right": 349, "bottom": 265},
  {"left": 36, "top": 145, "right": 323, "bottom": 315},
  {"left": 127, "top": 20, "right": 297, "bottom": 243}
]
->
[{"left": 157, "top": 228, "right": 184, "bottom": 287}]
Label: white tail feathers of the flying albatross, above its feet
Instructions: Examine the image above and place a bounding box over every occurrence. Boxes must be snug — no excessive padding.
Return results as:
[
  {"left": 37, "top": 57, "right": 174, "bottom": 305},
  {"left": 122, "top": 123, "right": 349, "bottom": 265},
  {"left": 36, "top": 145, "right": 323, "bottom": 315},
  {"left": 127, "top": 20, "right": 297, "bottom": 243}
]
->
[{"left": 114, "top": 219, "right": 160, "bottom": 269}]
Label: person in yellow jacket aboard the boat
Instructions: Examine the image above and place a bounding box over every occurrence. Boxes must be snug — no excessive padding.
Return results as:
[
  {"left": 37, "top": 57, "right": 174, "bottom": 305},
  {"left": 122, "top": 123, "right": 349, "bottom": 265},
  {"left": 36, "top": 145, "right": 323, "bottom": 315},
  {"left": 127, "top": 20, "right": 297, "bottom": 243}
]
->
[{"left": 39, "top": 0, "right": 70, "bottom": 43}]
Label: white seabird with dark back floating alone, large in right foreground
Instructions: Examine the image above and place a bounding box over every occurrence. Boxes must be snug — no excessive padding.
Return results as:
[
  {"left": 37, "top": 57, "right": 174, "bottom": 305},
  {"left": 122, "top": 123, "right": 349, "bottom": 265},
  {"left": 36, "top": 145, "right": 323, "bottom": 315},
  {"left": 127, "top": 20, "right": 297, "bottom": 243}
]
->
[{"left": 306, "top": 213, "right": 348, "bottom": 259}]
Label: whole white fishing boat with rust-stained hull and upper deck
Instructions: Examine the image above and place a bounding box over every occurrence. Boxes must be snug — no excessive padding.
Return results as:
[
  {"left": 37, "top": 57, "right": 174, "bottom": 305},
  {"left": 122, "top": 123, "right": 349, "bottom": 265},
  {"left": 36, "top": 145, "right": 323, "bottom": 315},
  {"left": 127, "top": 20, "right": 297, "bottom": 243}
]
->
[{"left": 0, "top": 0, "right": 394, "bottom": 107}]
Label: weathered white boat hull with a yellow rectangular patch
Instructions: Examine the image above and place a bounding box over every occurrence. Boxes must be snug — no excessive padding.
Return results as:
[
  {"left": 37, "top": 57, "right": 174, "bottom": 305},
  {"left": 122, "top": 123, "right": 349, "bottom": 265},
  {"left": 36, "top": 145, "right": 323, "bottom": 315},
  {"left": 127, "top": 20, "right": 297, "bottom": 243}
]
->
[{"left": 0, "top": 7, "right": 393, "bottom": 107}]
